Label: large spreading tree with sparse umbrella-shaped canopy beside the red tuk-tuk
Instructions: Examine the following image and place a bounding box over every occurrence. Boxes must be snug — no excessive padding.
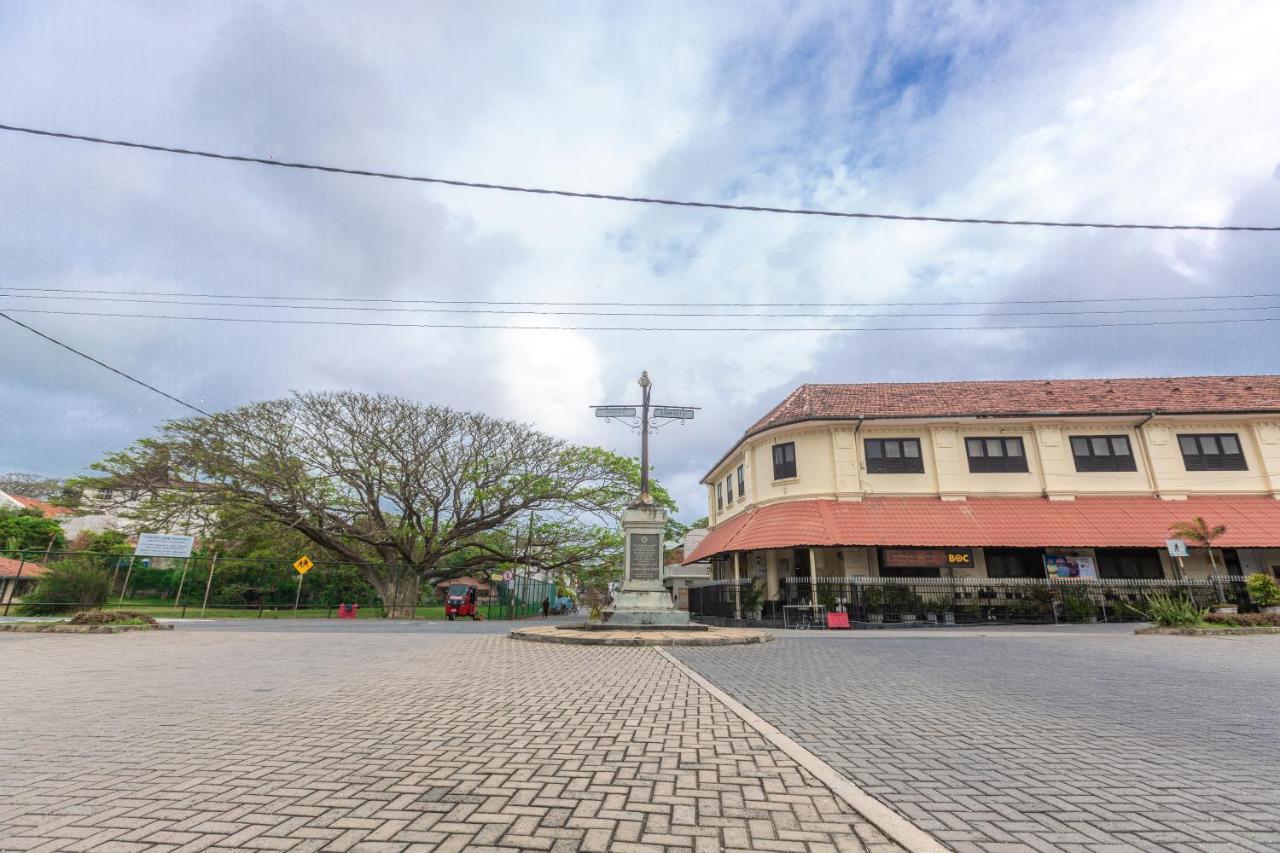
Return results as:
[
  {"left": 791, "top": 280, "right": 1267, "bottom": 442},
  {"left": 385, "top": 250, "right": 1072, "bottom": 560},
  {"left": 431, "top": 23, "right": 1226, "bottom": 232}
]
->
[{"left": 85, "top": 392, "right": 672, "bottom": 616}]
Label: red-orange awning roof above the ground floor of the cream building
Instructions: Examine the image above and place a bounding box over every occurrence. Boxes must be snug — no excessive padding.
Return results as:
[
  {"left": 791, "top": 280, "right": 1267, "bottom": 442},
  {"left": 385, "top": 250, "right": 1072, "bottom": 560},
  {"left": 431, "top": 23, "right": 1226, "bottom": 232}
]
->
[{"left": 685, "top": 496, "right": 1280, "bottom": 564}]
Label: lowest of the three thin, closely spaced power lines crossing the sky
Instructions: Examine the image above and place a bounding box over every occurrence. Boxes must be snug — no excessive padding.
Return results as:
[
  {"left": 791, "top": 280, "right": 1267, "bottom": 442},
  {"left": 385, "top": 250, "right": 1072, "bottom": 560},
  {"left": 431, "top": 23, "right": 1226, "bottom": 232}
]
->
[{"left": 5, "top": 307, "right": 1280, "bottom": 332}]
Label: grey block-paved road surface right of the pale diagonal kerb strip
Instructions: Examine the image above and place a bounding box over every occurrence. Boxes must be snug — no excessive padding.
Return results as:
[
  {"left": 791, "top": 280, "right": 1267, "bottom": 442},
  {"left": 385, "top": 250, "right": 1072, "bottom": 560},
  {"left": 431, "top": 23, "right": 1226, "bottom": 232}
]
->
[{"left": 672, "top": 629, "right": 1280, "bottom": 853}]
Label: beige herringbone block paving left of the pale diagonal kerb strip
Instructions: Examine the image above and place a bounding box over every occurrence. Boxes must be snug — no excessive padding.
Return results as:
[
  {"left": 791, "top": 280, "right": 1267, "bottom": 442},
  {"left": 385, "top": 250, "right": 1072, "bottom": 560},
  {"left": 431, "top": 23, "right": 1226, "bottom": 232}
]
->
[{"left": 0, "top": 626, "right": 899, "bottom": 853}]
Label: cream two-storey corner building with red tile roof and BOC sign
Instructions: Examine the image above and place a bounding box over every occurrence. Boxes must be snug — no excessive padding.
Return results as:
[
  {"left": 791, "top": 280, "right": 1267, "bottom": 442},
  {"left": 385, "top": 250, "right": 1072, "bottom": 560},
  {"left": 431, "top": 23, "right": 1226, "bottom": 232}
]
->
[{"left": 687, "top": 377, "right": 1280, "bottom": 598}]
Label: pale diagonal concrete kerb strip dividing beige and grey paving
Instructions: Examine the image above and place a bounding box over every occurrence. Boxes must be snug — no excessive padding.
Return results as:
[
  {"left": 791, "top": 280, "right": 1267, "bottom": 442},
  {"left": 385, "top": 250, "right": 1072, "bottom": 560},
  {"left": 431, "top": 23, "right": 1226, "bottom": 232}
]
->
[{"left": 654, "top": 648, "right": 950, "bottom": 853}]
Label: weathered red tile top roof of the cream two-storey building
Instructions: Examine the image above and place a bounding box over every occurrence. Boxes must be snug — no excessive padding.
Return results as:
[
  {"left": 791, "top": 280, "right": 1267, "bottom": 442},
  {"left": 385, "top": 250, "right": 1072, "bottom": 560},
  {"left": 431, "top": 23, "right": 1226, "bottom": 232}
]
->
[{"left": 746, "top": 375, "right": 1280, "bottom": 435}]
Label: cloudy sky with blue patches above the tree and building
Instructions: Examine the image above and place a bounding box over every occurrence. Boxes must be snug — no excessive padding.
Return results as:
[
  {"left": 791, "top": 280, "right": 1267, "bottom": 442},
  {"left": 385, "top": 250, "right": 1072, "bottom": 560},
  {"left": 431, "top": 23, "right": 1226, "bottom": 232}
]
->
[{"left": 0, "top": 0, "right": 1280, "bottom": 521}]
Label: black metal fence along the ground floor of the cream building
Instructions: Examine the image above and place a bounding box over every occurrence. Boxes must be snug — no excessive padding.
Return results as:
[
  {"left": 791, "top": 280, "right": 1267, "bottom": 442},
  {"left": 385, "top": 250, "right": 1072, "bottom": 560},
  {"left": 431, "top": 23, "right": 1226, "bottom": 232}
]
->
[{"left": 689, "top": 575, "right": 1251, "bottom": 626}]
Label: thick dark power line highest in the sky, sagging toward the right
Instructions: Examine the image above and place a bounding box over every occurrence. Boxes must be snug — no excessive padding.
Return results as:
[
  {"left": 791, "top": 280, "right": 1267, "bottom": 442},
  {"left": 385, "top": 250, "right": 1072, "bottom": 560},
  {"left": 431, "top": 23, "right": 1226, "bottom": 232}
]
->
[{"left": 0, "top": 124, "right": 1280, "bottom": 232}]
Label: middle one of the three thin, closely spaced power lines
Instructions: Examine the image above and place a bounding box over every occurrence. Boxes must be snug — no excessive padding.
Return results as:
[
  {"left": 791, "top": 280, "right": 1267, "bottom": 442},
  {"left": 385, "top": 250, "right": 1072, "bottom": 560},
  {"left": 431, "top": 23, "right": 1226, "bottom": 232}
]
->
[{"left": 0, "top": 293, "right": 1280, "bottom": 319}]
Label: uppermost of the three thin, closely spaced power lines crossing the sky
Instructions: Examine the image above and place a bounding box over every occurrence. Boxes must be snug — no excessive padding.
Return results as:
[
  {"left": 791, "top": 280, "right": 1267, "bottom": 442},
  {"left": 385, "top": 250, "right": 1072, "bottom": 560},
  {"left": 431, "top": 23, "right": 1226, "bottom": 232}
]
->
[{"left": 0, "top": 284, "right": 1280, "bottom": 310}]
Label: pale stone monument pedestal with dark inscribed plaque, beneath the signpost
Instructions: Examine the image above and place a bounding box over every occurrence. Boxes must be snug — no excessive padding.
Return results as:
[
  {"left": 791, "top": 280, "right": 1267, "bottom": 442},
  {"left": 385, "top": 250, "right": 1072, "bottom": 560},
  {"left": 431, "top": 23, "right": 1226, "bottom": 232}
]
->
[{"left": 603, "top": 502, "right": 689, "bottom": 628}]
